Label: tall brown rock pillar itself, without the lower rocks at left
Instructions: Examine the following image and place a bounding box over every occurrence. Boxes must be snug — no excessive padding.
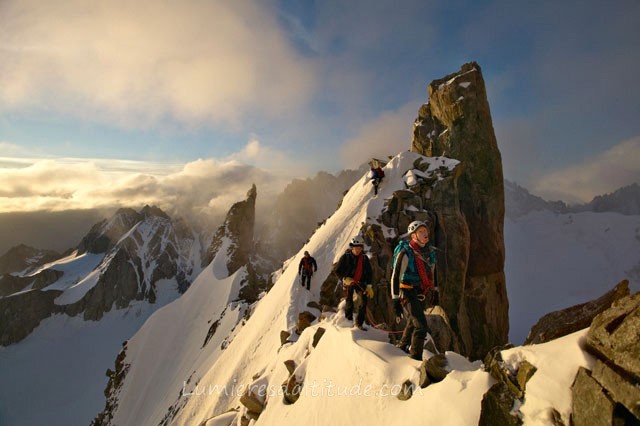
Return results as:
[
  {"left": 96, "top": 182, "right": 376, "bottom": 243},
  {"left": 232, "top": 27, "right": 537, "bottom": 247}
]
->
[{"left": 411, "top": 62, "right": 509, "bottom": 358}]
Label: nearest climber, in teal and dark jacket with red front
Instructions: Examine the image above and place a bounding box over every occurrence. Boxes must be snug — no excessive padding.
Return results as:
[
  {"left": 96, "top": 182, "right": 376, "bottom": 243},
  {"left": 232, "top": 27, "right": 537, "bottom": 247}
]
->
[{"left": 391, "top": 221, "right": 437, "bottom": 360}]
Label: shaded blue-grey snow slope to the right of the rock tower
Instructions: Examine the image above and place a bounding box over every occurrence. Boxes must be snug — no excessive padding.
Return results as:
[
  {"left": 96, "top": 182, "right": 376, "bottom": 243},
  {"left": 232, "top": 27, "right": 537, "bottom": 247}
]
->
[{"left": 504, "top": 210, "right": 640, "bottom": 344}]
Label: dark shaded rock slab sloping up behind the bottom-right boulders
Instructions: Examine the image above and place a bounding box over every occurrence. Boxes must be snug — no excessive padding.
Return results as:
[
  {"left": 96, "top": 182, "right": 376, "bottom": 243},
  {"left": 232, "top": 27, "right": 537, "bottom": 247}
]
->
[{"left": 524, "top": 280, "right": 629, "bottom": 345}]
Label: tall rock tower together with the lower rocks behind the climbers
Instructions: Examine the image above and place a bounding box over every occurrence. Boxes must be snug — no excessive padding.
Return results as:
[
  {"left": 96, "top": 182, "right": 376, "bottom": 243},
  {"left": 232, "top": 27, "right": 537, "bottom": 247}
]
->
[{"left": 320, "top": 63, "right": 509, "bottom": 359}]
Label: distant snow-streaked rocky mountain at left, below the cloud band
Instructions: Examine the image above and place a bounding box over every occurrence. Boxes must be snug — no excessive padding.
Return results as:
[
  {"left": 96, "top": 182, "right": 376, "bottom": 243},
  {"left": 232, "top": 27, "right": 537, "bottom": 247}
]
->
[{"left": 0, "top": 206, "right": 202, "bottom": 345}]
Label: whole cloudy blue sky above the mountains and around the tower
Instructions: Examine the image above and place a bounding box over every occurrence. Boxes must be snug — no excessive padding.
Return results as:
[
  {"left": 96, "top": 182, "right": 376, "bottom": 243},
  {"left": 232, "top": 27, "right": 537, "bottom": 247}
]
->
[{"left": 0, "top": 0, "right": 640, "bottom": 216}]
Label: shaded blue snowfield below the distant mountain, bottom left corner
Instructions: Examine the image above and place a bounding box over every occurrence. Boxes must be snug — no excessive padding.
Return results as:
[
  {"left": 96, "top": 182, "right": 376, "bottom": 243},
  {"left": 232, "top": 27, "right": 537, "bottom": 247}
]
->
[{"left": 0, "top": 280, "right": 176, "bottom": 426}]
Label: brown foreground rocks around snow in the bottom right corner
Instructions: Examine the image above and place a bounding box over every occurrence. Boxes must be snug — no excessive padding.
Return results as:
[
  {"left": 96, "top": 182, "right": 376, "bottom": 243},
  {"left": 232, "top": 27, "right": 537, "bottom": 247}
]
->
[{"left": 479, "top": 281, "right": 640, "bottom": 426}]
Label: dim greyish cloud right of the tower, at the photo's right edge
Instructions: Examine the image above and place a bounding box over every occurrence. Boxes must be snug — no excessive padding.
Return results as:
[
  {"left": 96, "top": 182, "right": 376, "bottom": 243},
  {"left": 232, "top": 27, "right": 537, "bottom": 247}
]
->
[{"left": 531, "top": 137, "right": 640, "bottom": 202}]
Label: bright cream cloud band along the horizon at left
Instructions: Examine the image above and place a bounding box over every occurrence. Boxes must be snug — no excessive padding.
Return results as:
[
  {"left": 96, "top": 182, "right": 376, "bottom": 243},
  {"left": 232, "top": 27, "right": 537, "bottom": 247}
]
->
[{"left": 0, "top": 140, "right": 291, "bottom": 218}]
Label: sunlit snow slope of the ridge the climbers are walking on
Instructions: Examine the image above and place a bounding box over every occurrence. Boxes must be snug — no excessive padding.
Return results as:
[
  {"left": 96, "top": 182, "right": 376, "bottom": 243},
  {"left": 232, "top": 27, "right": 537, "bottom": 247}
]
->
[{"left": 100, "top": 152, "right": 600, "bottom": 425}]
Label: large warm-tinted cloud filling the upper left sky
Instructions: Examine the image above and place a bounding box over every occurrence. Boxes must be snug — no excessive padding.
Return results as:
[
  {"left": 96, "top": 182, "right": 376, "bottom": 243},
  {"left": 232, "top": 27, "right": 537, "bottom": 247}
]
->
[{"left": 0, "top": 0, "right": 315, "bottom": 128}]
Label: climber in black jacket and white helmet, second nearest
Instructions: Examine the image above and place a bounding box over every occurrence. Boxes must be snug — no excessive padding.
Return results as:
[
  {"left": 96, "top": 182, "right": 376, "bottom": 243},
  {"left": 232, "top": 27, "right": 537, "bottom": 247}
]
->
[{"left": 335, "top": 236, "right": 373, "bottom": 330}]
